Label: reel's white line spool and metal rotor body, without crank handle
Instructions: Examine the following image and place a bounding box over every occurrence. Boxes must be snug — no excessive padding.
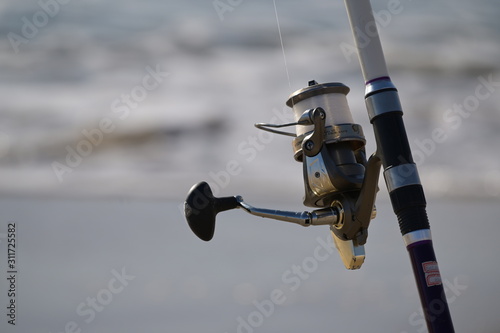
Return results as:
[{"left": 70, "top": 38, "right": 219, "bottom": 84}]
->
[{"left": 287, "top": 81, "right": 366, "bottom": 207}]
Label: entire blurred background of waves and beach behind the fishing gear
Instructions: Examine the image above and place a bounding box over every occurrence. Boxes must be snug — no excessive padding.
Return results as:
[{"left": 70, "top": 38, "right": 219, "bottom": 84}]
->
[{"left": 0, "top": 0, "right": 500, "bottom": 333}]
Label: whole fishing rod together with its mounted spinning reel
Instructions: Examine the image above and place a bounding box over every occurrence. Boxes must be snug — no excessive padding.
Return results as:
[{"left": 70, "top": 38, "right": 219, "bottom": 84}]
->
[{"left": 184, "top": 0, "right": 454, "bottom": 333}]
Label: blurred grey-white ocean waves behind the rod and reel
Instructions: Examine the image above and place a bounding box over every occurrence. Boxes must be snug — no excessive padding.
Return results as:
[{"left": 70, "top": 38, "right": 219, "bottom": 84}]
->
[{"left": 0, "top": 0, "right": 500, "bottom": 199}]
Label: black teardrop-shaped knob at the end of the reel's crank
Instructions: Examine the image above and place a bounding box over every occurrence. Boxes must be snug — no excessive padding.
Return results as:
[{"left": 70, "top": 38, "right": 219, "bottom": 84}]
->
[{"left": 184, "top": 182, "right": 239, "bottom": 242}]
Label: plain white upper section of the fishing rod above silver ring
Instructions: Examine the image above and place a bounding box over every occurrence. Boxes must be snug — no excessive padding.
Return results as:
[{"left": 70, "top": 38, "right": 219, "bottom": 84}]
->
[{"left": 345, "top": 0, "right": 389, "bottom": 83}]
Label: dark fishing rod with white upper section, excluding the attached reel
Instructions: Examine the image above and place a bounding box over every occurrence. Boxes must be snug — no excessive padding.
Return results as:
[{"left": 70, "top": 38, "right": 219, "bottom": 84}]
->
[{"left": 345, "top": 0, "right": 454, "bottom": 333}]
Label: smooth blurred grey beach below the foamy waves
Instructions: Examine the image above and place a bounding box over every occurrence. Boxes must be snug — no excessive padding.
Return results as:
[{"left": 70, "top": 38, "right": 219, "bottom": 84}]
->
[{"left": 0, "top": 198, "right": 500, "bottom": 333}]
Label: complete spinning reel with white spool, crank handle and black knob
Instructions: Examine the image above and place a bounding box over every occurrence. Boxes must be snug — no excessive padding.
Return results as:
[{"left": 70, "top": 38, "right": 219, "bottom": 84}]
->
[{"left": 184, "top": 81, "right": 381, "bottom": 269}]
